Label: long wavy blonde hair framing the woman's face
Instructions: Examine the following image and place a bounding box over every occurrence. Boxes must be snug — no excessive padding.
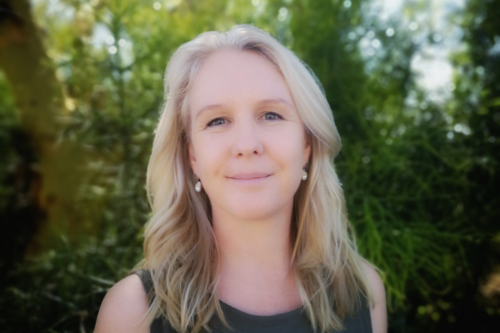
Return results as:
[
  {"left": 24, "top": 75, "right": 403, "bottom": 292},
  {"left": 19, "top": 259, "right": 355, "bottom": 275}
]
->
[{"left": 136, "top": 25, "right": 371, "bottom": 332}]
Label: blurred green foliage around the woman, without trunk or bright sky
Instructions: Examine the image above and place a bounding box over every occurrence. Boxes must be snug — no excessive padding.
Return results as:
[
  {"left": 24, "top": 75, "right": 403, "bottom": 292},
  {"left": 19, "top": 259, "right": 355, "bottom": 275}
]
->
[{"left": 0, "top": 0, "right": 500, "bottom": 332}]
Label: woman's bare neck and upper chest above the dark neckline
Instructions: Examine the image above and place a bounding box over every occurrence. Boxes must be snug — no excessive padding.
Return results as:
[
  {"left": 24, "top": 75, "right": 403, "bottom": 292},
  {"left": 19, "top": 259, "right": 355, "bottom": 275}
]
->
[{"left": 212, "top": 200, "right": 301, "bottom": 315}]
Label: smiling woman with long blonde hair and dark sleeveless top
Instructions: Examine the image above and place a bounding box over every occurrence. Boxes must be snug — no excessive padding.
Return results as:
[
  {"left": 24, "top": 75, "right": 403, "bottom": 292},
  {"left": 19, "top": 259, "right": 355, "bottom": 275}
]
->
[{"left": 95, "top": 25, "right": 387, "bottom": 333}]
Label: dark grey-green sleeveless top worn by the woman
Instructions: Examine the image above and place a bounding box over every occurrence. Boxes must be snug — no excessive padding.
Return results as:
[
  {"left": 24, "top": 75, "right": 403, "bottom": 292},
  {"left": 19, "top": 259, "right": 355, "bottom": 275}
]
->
[{"left": 134, "top": 270, "right": 372, "bottom": 333}]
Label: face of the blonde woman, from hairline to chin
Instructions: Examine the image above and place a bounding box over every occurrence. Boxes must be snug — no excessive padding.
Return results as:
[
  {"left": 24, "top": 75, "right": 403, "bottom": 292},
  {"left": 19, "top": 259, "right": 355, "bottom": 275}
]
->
[{"left": 189, "top": 50, "right": 311, "bottom": 219}]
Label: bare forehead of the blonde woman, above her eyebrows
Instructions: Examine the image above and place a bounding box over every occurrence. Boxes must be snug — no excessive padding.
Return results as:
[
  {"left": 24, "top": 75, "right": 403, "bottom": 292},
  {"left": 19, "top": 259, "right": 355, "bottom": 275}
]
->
[{"left": 189, "top": 50, "right": 293, "bottom": 112}]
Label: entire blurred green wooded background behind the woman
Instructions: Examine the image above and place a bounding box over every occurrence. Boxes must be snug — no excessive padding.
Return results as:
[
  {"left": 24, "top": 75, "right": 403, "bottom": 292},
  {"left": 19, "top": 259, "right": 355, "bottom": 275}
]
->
[{"left": 0, "top": 0, "right": 500, "bottom": 332}]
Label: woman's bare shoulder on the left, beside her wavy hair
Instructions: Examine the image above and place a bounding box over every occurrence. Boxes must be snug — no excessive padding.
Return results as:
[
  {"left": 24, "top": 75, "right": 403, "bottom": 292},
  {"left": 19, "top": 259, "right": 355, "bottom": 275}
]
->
[{"left": 94, "top": 274, "right": 149, "bottom": 333}]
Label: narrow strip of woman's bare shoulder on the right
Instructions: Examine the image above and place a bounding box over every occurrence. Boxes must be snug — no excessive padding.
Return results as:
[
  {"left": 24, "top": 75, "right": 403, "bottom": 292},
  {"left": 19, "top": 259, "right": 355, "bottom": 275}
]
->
[{"left": 363, "top": 262, "right": 387, "bottom": 333}]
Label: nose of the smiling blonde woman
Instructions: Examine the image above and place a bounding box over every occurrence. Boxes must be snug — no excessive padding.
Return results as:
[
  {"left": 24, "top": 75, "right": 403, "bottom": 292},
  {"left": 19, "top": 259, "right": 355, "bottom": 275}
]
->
[{"left": 232, "top": 117, "right": 264, "bottom": 157}]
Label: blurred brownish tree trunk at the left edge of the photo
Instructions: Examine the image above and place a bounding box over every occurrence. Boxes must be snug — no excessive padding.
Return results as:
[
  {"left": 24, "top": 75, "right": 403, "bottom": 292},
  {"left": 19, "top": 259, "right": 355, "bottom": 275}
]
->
[{"left": 0, "top": 0, "right": 80, "bottom": 254}]
